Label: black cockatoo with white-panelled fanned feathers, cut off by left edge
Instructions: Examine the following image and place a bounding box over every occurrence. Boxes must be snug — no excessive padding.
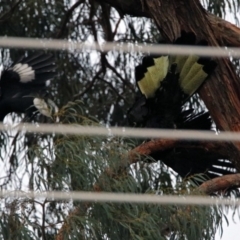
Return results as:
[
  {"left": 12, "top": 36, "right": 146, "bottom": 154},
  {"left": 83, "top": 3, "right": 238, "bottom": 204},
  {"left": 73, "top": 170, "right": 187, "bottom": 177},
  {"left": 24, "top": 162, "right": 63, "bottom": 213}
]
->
[{"left": 0, "top": 53, "right": 57, "bottom": 121}]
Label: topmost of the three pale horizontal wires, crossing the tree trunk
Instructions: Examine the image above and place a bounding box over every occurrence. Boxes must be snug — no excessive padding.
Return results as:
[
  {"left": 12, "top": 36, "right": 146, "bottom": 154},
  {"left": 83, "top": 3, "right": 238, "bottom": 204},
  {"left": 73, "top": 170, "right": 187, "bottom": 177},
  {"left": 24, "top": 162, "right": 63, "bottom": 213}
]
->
[{"left": 0, "top": 37, "right": 240, "bottom": 58}]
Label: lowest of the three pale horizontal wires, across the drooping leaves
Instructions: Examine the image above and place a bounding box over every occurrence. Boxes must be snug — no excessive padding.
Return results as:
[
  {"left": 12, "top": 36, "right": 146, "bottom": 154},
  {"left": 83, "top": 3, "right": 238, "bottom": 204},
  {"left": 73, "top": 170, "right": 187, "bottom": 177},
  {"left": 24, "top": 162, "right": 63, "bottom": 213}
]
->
[{"left": 0, "top": 190, "right": 240, "bottom": 206}]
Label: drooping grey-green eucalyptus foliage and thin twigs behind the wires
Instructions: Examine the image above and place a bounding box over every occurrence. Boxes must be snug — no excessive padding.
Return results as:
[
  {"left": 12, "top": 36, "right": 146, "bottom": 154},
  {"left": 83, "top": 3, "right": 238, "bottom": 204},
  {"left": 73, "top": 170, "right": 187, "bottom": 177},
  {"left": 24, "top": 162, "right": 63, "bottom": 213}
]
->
[{"left": 0, "top": 0, "right": 239, "bottom": 240}]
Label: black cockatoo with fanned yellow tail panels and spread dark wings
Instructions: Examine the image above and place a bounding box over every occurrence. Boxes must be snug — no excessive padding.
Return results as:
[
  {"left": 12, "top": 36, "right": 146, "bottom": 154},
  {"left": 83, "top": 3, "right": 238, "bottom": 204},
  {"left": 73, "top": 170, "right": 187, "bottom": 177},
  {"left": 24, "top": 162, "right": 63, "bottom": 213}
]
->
[{"left": 128, "top": 32, "right": 235, "bottom": 181}]
